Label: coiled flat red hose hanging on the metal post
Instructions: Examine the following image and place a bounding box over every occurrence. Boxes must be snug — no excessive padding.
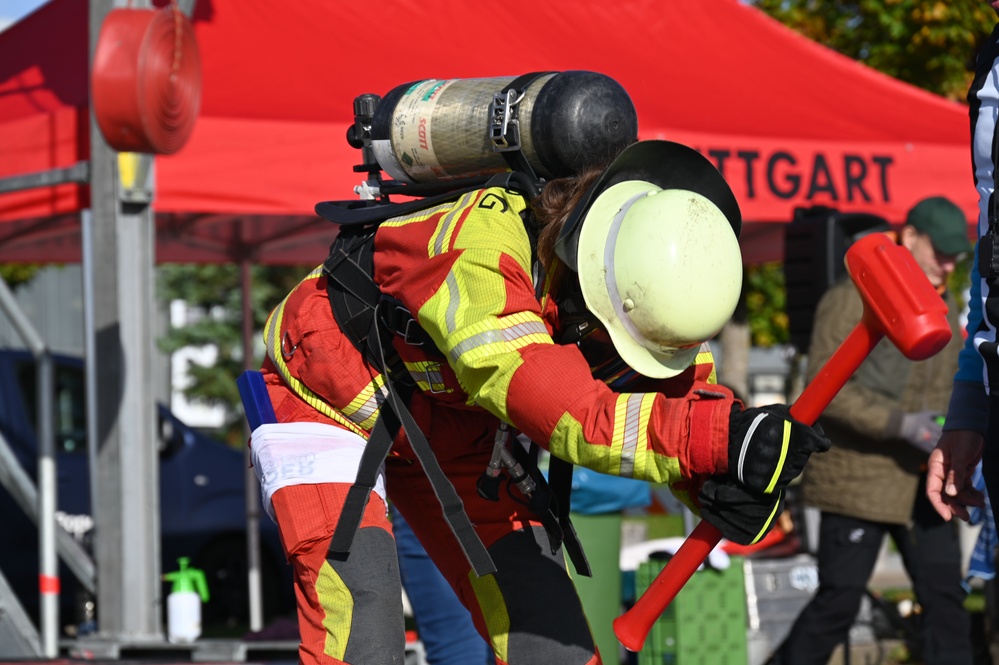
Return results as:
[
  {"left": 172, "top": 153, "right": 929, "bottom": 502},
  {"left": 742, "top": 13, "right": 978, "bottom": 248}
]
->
[{"left": 90, "top": 5, "right": 201, "bottom": 155}]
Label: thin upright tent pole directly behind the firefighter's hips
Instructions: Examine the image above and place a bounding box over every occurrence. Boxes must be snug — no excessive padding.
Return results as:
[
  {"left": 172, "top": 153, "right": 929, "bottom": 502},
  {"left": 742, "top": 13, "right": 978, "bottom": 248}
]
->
[{"left": 239, "top": 254, "right": 264, "bottom": 631}]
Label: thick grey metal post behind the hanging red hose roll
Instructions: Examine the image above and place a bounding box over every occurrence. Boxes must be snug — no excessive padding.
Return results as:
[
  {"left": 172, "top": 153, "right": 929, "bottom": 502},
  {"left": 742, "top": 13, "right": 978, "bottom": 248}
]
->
[{"left": 86, "top": 0, "right": 163, "bottom": 643}]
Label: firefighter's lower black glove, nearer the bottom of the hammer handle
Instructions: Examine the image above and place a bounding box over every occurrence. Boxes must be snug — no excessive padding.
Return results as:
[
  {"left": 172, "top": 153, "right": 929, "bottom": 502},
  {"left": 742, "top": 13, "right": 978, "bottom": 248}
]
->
[{"left": 699, "top": 475, "right": 784, "bottom": 545}]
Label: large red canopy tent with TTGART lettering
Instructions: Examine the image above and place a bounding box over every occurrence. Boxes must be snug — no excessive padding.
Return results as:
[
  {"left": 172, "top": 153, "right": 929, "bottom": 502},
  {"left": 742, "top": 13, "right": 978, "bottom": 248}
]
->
[{"left": 0, "top": 0, "right": 976, "bottom": 263}]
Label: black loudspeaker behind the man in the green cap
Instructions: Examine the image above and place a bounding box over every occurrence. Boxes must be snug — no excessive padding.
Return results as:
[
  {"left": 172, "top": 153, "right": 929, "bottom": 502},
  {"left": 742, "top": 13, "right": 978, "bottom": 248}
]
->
[{"left": 784, "top": 206, "right": 891, "bottom": 353}]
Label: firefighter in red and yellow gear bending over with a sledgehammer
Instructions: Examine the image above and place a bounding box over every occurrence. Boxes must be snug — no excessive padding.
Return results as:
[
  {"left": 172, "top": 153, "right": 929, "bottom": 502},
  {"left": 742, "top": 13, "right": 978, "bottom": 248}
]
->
[{"left": 251, "top": 141, "right": 829, "bottom": 665}]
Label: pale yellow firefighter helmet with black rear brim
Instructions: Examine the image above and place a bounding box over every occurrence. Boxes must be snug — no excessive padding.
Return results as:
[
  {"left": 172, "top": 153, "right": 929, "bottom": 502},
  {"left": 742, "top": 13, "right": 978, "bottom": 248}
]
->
[{"left": 556, "top": 141, "right": 742, "bottom": 378}]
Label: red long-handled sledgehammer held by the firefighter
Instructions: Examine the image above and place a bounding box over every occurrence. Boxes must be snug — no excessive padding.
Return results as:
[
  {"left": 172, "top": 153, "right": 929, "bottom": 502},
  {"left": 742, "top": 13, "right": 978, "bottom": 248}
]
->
[{"left": 614, "top": 233, "right": 951, "bottom": 651}]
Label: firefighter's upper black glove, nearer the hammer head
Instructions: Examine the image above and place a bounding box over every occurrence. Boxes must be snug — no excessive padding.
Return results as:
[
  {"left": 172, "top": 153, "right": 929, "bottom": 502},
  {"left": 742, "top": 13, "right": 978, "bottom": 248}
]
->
[{"left": 728, "top": 403, "right": 830, "bottom": 494}]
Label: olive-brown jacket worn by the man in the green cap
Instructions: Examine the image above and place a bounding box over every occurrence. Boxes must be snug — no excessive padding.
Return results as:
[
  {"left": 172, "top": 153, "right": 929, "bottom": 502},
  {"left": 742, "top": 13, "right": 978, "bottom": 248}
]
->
[{"left": 802, "top": 278, "right": 963, "bottom": 524}]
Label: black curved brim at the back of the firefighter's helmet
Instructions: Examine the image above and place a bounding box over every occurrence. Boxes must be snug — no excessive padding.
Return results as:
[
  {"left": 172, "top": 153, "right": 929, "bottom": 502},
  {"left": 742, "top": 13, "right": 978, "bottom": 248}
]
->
[{"left": 555, "top": 140, "right": 742, "bottom": 272}]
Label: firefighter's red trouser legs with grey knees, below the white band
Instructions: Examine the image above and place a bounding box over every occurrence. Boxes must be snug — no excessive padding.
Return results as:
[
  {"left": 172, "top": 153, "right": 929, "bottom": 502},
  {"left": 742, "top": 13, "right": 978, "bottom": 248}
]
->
[{"left": 272, "top": 449, "right": 600, "bottom": 665}]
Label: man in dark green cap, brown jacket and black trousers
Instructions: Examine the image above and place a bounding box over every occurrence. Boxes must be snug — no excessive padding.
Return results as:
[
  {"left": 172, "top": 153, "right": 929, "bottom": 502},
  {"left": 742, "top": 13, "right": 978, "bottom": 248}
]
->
[{"left": 770, "top": 196, "right": 973, "bottom": 665}]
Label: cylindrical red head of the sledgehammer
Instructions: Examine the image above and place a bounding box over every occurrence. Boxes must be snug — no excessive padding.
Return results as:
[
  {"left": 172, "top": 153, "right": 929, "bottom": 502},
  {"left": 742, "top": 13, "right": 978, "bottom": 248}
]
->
[{"left": 845, "top": 233, "right": 951, "bottom": 360}]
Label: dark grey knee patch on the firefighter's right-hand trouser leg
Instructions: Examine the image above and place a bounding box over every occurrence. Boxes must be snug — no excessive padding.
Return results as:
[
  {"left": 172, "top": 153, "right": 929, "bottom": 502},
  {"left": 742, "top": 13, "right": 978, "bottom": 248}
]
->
[{"left": 489, "top": 527, "right": 596, "bottom": 665}]
